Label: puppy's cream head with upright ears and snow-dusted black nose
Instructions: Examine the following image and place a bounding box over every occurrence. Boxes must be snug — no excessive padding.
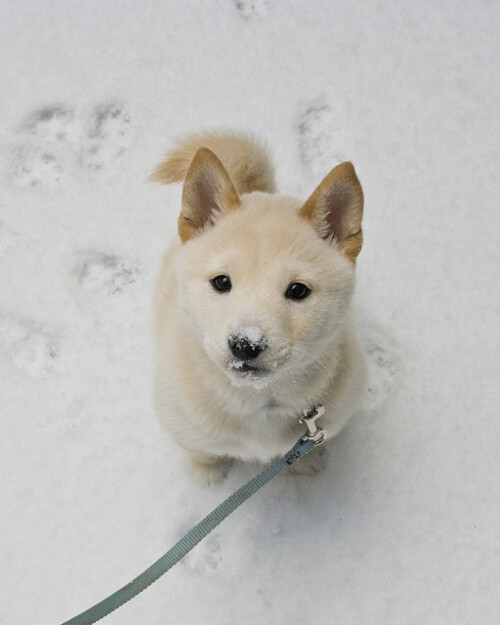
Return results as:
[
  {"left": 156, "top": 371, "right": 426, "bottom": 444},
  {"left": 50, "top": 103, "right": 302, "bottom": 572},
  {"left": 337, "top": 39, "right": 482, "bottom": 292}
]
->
[{"left": 176, "top": 148, "right": 363, "bottom": 388}]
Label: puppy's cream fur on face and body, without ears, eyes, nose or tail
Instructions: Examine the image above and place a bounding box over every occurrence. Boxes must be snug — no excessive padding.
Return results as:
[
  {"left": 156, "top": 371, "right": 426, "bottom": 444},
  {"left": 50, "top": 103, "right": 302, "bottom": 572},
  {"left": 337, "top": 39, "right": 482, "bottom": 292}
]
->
[{"left": 150, "top": 132, "right": 364, "bottom": 483}]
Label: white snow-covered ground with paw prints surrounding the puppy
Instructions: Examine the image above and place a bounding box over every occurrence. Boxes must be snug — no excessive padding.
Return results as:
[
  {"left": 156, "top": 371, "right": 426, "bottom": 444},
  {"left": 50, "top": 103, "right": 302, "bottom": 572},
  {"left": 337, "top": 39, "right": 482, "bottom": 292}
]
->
[{"left": 0, "top": 0, "right": 500, "bottom": 625}]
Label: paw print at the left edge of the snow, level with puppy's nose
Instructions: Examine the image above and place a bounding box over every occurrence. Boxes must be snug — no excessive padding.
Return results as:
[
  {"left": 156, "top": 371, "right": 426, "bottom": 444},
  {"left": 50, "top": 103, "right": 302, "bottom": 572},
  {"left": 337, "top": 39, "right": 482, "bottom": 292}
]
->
[{"left": 0, "top": 315, "right": 60, "bottom": 379}]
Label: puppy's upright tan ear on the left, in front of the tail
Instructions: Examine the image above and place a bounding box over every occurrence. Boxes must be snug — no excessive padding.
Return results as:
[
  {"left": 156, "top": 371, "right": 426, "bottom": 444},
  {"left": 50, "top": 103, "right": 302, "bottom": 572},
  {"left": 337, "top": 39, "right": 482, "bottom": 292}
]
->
[{"left": 178, "top": 148, "right": 240, "bottom": 243}]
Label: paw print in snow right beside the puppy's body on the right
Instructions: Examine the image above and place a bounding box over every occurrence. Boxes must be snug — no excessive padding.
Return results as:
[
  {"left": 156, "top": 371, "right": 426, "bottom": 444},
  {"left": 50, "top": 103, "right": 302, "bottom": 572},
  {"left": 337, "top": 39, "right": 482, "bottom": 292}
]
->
[{"left": 363, "top": 325, "right": 400, "bottom": 409}]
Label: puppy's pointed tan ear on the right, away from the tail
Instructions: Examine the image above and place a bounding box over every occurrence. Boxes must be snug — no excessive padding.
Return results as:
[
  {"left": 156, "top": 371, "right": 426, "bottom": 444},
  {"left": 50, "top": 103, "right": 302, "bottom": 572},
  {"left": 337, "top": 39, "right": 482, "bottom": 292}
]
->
[{"left": 299, "top": 163, "right": 363, "bottom": 263}]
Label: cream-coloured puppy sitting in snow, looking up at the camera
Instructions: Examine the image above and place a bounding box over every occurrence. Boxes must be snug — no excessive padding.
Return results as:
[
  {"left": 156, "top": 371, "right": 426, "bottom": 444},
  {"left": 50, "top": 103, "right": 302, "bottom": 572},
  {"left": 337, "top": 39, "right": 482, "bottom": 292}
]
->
[{"left": 152, "top": 133, "right": 364, "bottom": 484}]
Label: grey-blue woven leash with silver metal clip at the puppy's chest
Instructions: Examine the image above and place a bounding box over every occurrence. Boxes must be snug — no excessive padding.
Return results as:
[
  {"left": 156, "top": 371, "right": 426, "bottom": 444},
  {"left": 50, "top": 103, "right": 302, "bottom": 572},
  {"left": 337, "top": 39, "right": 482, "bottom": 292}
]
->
[{"left": 58, "top": 406, "right": 325, "bottom": 625}]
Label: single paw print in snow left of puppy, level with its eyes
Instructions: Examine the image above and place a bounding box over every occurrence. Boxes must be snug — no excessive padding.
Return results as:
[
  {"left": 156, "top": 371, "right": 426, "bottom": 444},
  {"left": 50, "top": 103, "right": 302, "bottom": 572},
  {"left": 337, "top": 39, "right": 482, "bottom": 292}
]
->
[{"left": 75, "top": 252, "right": 140, "bottom": 296}]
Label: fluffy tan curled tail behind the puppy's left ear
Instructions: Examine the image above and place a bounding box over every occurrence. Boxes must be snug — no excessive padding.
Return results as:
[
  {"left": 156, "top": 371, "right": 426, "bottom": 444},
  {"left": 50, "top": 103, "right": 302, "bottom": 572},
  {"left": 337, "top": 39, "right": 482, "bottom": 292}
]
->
[{"left": 150, "top": 132, "right": 275, "bottom": 194}]
